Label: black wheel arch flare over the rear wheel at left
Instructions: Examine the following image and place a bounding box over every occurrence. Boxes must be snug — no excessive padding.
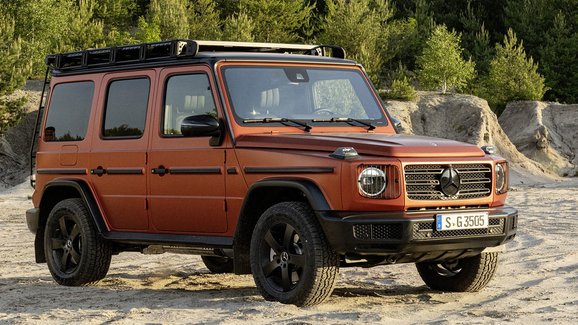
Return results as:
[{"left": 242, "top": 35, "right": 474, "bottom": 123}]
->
[{"left": 34, "top": 179, "right": 108, "bottom": 263}]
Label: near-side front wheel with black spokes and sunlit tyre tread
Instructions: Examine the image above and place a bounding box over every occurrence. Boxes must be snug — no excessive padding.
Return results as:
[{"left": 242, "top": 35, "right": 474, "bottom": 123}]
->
[{"left": 251, "top": 202, "right": 339, "bottom": 306}]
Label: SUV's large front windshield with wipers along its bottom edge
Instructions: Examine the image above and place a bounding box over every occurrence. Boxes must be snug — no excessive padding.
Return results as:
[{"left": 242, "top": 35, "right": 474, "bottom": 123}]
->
[{"left": 223, "top": 66, "right": 387, "bottom": 126}]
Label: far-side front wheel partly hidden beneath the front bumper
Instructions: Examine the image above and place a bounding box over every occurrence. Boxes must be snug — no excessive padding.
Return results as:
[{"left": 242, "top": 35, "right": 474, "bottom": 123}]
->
[{"left": 416, "top": 253, "right": 499, "bottom": 292}]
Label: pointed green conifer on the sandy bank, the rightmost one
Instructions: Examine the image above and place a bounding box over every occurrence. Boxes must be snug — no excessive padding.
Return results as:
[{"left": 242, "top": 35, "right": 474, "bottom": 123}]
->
[{"left": 481, "top": 29, "right": 547, "bottom": 115}]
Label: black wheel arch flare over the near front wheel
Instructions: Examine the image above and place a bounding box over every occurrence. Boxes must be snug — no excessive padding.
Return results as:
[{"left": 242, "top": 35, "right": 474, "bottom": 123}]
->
[{"left": 234, "top": 179, "right": 331, "bottom": 274}]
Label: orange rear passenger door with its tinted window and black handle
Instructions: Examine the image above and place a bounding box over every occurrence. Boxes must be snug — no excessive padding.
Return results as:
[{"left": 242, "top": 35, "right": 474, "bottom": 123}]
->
[{"left": 90, "top": 70, "right": 155, "bottom": 231}]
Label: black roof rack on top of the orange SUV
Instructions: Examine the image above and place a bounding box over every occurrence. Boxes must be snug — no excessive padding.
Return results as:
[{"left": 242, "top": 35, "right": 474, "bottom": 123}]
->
[{"left": 45, "top": 40, "right": 345, "bottom": 70}]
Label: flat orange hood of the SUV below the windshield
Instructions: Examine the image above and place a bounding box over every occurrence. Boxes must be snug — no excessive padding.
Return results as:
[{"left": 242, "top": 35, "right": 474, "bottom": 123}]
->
[{"left": 236, "top": 133, "right": 485, "bottom": 158}]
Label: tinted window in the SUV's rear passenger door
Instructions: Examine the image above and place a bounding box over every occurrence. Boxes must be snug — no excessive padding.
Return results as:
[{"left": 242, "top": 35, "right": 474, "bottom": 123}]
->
[{"left": 102, "top": 78, "right": 150, "bottom": 138}]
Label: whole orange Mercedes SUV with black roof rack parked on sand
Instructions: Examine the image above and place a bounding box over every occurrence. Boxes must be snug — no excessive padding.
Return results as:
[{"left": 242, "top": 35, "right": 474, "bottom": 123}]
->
[{"left": 26, "top": 40, "right": 517, "bottom": 306}]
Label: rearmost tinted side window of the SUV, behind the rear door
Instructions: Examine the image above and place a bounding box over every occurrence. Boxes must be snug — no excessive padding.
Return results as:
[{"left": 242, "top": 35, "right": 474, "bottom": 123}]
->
[{"left": 44, "top": 81, "right": 94, "bottom": 141}]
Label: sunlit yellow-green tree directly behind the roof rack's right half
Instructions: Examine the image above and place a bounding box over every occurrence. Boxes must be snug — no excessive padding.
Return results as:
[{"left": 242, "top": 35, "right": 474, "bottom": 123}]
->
[{"left": 238, "top": 0, "right": 312, "bottom": 43}]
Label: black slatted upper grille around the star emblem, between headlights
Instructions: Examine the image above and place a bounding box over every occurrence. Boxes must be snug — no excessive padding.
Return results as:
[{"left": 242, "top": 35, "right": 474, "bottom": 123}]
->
[{"left": 404, "top": 164, "right": 492, "bottom": 200}]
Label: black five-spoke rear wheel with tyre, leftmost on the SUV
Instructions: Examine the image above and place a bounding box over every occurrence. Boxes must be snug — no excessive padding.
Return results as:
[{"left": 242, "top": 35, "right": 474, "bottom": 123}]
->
[{"left": 44, "top": 199, "right": 112, "bottom": 286}]
